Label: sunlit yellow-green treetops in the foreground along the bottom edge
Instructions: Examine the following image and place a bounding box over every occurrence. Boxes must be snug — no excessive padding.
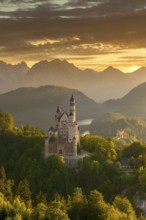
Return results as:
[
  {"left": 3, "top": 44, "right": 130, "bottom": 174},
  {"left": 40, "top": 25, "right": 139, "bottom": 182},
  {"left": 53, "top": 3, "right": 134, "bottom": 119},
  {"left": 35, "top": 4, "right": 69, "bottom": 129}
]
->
[{"left": 0, "top": 184, "right": 139, "bottom": 220}]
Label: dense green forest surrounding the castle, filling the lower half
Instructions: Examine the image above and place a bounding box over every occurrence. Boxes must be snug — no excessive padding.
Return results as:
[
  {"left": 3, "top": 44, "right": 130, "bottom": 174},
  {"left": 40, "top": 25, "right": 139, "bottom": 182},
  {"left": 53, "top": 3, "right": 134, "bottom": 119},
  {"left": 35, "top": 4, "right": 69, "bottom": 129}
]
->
[{"left": 0, "top": 112, "right": 146, "bottom": 220}]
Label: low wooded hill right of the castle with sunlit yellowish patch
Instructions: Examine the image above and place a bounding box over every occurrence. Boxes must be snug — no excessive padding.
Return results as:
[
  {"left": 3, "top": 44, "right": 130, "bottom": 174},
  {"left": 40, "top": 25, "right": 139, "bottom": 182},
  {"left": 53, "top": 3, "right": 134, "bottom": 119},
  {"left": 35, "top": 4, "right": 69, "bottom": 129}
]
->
[{"left": 89, "top": 113, "right": 146, "bottom": 141}]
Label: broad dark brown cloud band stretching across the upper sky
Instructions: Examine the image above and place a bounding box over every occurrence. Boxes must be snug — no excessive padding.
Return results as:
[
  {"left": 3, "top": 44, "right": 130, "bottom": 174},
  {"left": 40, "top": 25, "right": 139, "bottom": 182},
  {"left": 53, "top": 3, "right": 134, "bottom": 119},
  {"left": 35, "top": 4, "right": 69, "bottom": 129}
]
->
[{"left": 0, "top": 10, "right": 146, "bottom": 48}]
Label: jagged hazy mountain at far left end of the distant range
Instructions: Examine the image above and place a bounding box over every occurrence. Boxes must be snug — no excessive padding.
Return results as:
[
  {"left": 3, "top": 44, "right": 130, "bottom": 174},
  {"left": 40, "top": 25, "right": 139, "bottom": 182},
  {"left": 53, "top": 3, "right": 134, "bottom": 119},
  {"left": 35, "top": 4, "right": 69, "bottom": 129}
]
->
[{"left": 0, "top": 61, "right": 29, "bottom": 93}]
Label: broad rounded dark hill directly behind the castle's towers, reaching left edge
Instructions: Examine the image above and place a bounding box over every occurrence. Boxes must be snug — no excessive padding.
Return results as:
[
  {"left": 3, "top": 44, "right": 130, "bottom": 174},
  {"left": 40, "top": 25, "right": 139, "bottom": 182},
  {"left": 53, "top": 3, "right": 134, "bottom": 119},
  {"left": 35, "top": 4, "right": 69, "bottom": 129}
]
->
[{"left": 0, "top": 86, "right": 98, "bottom": 130}]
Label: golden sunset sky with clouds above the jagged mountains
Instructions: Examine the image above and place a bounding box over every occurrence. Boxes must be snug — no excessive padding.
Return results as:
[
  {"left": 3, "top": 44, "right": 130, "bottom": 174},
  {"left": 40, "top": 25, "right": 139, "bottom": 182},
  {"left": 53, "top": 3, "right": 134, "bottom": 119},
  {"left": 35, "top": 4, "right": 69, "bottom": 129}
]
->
[{"left": 0, "top": 0, "right": 146, "bottom": 72}]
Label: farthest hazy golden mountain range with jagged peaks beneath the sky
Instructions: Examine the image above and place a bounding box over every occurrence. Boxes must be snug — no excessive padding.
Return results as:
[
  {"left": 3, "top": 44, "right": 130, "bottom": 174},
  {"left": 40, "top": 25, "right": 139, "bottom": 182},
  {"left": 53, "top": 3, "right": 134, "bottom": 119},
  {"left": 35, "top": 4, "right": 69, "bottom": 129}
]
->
[{"left": 0, "top": 59, "right": 146, "bottom": 102}]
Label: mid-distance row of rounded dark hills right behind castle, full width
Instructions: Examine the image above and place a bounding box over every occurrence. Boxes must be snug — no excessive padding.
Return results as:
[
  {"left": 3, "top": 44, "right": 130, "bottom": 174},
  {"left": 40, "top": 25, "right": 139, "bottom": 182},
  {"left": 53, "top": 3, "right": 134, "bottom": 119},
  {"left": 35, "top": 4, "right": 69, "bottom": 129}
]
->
[{"left": 0, "top": 82, "right": 146, "bottom": 130}]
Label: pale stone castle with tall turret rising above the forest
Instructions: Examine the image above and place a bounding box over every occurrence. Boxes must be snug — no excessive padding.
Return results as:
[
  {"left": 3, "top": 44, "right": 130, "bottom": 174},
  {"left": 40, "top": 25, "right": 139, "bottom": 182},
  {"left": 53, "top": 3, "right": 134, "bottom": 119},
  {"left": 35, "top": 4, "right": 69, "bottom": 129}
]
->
[{"left": 44, "top": 95, "right": 83, "bottom": 167}]
